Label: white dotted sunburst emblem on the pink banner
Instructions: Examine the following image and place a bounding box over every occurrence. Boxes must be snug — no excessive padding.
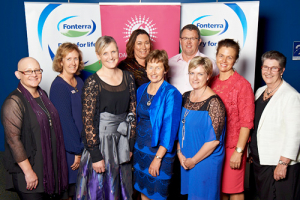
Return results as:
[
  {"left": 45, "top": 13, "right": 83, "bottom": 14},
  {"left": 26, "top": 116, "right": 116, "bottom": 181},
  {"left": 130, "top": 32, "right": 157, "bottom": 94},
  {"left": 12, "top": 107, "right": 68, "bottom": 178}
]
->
[{"left": 123, "top": 15, "right": 158, "bottom": 42}]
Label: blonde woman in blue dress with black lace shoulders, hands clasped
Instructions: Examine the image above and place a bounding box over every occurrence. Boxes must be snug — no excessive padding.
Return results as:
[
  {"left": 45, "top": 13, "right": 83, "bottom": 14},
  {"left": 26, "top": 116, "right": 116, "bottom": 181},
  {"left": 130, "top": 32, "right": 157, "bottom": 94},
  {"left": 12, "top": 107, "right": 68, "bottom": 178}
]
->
[{"left": 177, "top": 56, "right": 225, "bottom": 200}]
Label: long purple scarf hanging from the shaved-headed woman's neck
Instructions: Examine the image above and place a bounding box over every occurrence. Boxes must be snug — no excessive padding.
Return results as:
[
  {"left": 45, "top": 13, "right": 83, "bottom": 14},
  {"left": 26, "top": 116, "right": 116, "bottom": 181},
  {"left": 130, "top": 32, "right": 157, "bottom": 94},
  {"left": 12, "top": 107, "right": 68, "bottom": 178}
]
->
[{"left": 18, "top": 83, "right": 68, "bottom": 194}]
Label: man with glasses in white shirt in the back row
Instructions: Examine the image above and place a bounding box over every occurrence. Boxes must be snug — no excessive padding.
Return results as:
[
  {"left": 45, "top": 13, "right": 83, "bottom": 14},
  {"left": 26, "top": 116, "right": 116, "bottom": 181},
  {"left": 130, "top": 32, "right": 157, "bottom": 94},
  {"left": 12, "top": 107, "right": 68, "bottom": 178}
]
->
[{"left": 168, "top": 24, "right": 219, "bottom": 94}]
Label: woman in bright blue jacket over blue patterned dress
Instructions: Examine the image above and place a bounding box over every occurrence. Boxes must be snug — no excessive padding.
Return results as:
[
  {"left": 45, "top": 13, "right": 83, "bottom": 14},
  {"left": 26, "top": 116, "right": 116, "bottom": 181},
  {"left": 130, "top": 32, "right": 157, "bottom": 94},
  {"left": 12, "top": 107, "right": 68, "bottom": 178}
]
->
[{"left": 133, "top": 50, "right": 182, "bottom": 200}]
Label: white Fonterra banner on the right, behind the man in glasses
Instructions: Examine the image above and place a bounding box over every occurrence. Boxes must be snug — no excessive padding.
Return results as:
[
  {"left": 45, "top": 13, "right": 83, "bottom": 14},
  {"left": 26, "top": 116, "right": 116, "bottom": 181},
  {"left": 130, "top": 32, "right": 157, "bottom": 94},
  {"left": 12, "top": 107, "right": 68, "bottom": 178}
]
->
[{"left": 181, "top": 1, "right": 259, "bottom": 89}]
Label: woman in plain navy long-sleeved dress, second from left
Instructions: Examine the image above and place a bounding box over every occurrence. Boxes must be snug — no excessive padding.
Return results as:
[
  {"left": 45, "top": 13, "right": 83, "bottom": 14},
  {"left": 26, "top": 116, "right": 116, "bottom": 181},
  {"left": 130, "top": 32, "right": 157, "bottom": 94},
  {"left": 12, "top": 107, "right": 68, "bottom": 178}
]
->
[{"left": 50, "top": 42, "right": 84, "bottom": 200}]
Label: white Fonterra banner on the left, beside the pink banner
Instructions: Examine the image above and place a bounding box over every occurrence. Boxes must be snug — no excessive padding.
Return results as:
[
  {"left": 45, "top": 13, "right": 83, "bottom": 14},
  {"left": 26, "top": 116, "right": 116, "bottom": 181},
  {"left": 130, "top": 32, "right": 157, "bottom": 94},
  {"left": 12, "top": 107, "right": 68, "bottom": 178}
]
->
[{"left": 25, "top": 2, "right": 101, "bottom": 94}]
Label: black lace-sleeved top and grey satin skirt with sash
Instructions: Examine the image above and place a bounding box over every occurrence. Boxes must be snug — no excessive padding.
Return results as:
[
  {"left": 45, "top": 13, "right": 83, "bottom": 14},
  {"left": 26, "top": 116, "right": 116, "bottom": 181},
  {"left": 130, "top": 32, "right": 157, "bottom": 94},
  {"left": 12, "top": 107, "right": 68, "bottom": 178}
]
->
[{"left": 76, "top": 71, "right": 136, "bottom": 200}]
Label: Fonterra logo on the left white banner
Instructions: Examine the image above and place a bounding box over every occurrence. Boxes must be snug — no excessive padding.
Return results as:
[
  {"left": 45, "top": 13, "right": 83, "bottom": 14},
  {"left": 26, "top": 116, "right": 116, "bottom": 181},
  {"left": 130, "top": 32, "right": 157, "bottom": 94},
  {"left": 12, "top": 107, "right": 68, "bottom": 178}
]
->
[{"left": 57, "top": 16, "right": 96, "bottom": 37}]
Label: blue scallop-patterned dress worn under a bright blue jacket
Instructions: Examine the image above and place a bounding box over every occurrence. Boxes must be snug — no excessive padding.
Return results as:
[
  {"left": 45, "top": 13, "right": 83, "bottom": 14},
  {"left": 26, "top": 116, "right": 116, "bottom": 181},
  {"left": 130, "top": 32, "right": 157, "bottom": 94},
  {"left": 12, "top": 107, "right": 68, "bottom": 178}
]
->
[{"left": 133, "top": 91, "right": 175, "bottom": 200}]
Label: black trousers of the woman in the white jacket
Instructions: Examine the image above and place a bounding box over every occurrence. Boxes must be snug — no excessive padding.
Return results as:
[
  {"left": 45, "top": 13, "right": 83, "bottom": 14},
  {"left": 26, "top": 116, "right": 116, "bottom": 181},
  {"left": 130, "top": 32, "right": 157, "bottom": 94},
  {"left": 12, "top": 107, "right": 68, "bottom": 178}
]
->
[{"left": 253, "top": 156, "right": 300, "bottom": 200}]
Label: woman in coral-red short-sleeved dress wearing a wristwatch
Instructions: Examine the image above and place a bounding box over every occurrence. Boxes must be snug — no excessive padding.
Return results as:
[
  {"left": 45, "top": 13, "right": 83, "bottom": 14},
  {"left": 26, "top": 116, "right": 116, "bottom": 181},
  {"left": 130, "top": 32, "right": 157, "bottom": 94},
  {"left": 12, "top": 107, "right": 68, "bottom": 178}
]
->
[{"left": 211, "top": 39, "right": 254, "bottom": 199}]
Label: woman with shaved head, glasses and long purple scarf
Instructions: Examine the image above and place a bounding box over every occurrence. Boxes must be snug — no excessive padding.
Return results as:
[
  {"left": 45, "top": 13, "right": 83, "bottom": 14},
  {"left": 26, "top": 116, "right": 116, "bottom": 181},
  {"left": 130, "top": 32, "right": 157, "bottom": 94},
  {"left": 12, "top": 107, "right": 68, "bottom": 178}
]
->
[{"left": 1, "top": 57, "right": 68, "bottom": 200}]
